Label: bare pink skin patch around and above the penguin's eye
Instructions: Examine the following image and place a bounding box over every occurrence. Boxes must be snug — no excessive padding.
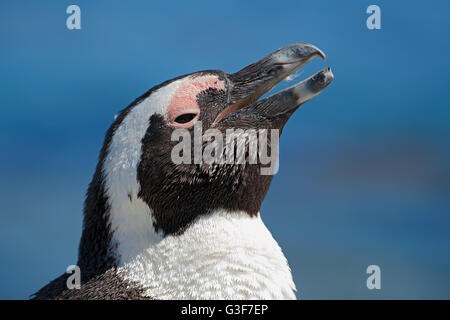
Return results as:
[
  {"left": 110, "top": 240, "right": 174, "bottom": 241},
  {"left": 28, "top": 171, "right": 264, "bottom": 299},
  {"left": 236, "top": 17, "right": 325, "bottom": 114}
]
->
[{"left": 167, "top": 76, "right": 225, "bottom": 128}]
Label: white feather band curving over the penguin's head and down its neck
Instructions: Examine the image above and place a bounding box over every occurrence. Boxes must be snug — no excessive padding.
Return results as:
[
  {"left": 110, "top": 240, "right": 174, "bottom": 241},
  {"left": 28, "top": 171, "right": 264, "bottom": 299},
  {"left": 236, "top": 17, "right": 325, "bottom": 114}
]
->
[{"left": 103, "top": 75, "right": 223, "bottom": 261}]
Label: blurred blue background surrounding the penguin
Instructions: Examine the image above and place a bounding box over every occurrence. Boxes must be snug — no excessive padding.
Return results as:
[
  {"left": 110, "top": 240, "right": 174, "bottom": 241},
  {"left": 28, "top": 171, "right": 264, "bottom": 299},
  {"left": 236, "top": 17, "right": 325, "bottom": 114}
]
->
[{"left": 0, "top": 0, "right": 450, "bottom": 299}]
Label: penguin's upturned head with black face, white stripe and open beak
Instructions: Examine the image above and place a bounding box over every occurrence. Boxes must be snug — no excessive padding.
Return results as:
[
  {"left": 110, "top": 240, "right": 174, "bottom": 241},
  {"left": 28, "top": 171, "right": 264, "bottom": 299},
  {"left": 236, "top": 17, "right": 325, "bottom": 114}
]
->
[{"left": 101, "top": 44, "right": 333, "bottom": 234}]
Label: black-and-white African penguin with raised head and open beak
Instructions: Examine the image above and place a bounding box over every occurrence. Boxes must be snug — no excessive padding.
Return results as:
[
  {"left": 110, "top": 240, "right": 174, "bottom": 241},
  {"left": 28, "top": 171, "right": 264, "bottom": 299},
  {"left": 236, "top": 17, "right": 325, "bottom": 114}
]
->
[{"left": 34, "top": 44, "right": 333, "bottom": 299}]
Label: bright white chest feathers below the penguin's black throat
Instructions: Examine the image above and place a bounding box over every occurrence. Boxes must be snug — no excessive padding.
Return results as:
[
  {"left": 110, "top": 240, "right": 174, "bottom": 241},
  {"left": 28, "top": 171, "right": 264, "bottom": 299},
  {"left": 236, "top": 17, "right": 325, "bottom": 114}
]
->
[{"left": 119, "top": 212, "right": 295, "bottom": 299}]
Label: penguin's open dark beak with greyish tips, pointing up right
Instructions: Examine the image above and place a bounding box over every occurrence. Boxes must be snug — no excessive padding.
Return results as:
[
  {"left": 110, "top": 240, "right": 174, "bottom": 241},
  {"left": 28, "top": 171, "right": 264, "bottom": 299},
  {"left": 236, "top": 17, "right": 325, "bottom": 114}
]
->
[{"left": 215, "top": 43, "right": 333, "bottom": 127}]
